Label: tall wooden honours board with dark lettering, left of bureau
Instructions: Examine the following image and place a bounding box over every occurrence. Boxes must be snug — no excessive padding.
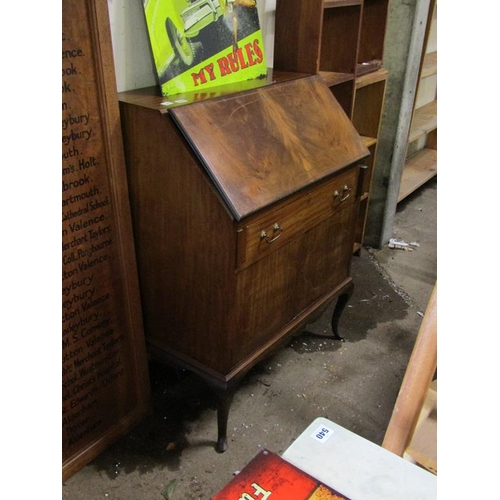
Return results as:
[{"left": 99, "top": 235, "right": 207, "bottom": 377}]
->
[{"left": 62, "top": 0, "right": 149, "bottom": 481}]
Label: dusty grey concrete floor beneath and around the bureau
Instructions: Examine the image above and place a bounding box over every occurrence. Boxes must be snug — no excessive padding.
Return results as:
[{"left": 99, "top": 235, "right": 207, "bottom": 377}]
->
[{"left": 62, "top": 179, "right": 437, "bottom": 500}]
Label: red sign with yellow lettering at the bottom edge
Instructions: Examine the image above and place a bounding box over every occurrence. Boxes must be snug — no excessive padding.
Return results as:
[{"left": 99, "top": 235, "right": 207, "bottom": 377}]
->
[{"left": 211, "top": 450, "right": 349, "bottom": 500}]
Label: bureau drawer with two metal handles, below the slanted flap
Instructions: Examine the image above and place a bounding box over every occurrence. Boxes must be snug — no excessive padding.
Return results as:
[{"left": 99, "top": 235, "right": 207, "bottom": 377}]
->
[{"left": 237, "top": 167, "right": 359, "bottom": 268}]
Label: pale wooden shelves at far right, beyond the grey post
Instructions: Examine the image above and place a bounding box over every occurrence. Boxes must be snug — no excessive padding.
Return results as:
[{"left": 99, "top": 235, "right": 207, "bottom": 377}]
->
[{"left": 398, "top": 0, "right": 437, "bottom": 203}]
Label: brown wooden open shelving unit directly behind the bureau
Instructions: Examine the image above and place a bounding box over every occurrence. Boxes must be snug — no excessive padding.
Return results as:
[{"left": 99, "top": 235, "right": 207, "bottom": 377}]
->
[{"left": 274, "top": 0, "right": 388, "bottom": 252}]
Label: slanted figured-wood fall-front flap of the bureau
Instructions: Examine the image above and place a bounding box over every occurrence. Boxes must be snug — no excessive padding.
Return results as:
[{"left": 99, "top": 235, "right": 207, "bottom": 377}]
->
[{"left": 169, "top": 76, "right": 369, "bottom": 220}]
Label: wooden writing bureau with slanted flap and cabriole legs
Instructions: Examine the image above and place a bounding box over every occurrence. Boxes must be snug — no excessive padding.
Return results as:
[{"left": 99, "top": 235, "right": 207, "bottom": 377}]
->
[{"left": 120, "top": 76, "right": 369, "bottom": 451}]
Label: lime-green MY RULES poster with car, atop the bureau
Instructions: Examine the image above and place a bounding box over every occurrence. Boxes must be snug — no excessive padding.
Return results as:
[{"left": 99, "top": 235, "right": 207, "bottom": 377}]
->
[{"left": 144, "top": 0, "right": 267, "bottom": 96}]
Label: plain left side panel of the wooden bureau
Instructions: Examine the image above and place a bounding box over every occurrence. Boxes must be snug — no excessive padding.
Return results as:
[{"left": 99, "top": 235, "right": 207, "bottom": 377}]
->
[{"left": 121, "top": 103, "right": 236, "bottom": 373}]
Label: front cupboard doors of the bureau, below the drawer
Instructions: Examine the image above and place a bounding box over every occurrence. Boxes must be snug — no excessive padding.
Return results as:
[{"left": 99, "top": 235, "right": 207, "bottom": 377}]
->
[{"left": 230, "top": 203, "right": 357, "bottom": 370}]
